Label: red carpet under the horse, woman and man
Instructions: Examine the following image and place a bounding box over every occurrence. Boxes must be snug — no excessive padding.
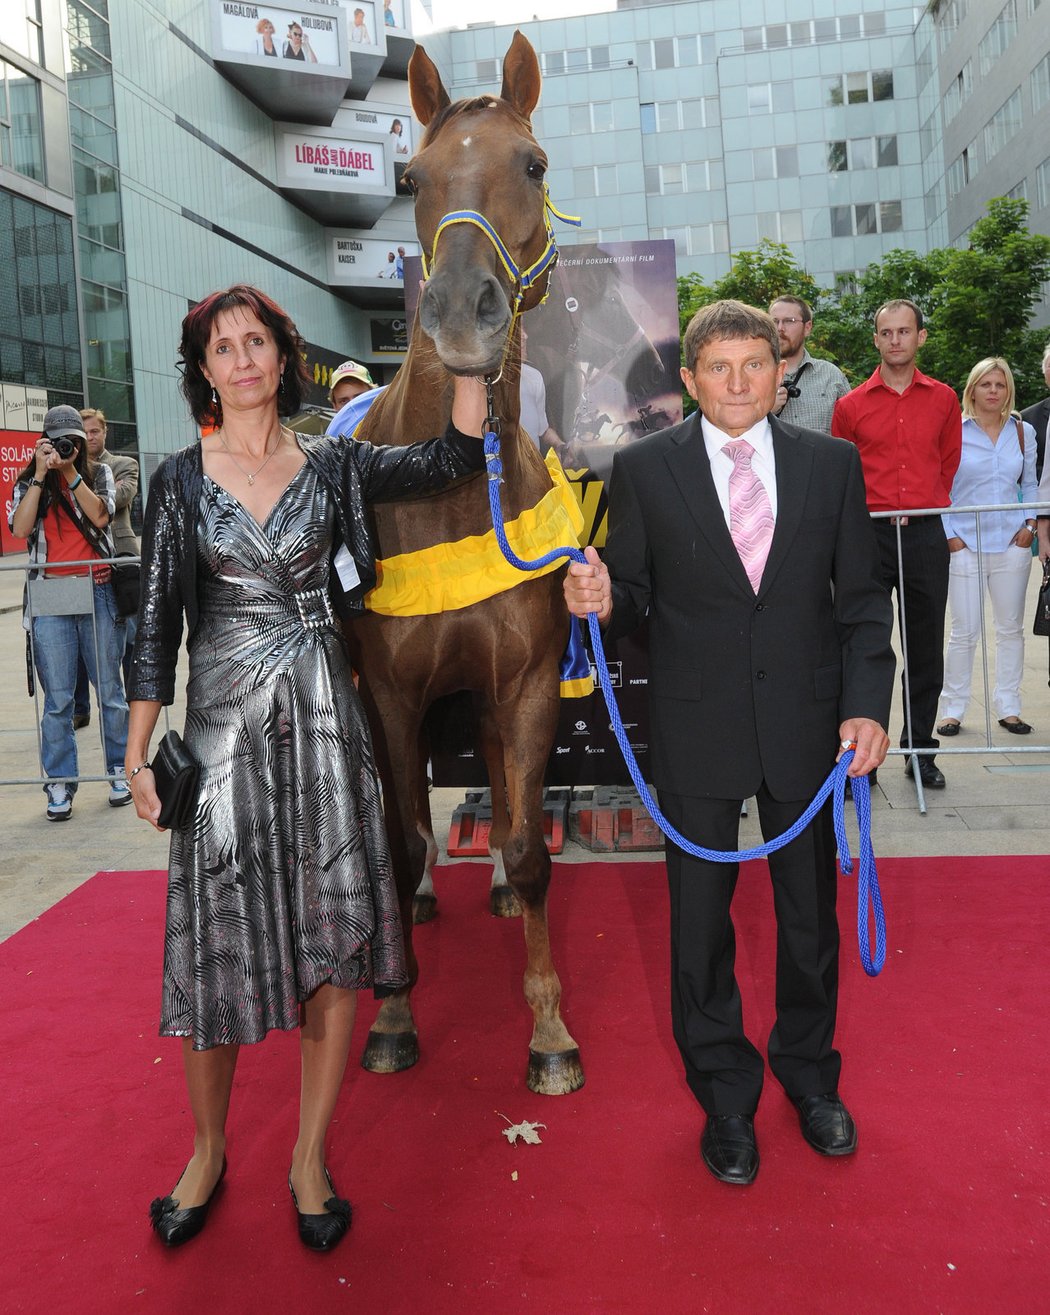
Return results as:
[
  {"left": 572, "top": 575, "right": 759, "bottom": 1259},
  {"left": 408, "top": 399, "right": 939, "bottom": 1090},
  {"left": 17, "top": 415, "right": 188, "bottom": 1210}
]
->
[{"left": 0, "top": 857, "right": 1050, "bottom": 1315}]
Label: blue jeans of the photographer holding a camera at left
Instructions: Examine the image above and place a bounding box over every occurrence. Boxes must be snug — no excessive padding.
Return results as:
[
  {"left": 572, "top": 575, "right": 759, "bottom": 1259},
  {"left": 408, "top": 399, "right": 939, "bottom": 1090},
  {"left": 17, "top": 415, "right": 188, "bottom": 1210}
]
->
[{"left": 33, "top": 583, "right": 128, "bottom": 793}]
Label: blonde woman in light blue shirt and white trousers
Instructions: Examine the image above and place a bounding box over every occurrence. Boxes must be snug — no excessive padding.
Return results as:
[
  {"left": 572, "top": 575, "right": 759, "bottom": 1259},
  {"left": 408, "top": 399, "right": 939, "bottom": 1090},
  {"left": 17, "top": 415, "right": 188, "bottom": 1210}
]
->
[{"left": 937, "top": 356, "right": 1037, "bottom": 735}]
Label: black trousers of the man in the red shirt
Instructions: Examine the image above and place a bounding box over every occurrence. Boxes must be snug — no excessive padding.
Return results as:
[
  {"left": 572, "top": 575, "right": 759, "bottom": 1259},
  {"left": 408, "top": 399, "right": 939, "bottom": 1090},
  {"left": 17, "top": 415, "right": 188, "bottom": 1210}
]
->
[{"left": 872, "top": 515, "right": 951, "bottom": 748}]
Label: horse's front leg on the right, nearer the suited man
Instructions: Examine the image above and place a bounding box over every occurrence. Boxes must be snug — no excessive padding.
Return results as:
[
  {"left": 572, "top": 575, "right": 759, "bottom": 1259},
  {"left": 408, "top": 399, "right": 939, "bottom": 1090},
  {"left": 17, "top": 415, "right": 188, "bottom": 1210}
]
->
[{"left": 493, "top": 696, "right": 584, "bottom": 1095}]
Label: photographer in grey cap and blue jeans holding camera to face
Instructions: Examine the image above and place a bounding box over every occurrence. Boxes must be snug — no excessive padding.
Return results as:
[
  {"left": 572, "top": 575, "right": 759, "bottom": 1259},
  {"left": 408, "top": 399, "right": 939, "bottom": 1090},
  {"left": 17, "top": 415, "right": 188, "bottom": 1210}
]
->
[{"left": 9, "top": 406, "right": 132, "bottom": 822}]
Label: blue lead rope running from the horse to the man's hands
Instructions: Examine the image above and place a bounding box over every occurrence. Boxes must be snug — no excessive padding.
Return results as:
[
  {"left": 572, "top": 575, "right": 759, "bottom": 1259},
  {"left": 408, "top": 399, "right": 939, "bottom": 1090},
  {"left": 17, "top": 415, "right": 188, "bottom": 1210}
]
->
[{"left": 484, "top": 429, "right": 886, "bottom": 977}]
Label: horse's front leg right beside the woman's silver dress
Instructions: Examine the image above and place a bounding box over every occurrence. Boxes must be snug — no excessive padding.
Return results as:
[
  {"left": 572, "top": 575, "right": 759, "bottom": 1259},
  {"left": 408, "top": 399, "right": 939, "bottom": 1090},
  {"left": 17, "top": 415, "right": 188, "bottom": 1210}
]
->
[{"left": 361, "top": 681, "right": 426, "bottom": 1073}]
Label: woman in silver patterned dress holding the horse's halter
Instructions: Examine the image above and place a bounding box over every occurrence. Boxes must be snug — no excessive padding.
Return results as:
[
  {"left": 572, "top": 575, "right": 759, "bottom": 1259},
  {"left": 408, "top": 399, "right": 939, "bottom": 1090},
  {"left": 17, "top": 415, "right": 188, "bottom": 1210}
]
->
[{"left": 126, "top": 285, "right": 484, "bottom": 1251}]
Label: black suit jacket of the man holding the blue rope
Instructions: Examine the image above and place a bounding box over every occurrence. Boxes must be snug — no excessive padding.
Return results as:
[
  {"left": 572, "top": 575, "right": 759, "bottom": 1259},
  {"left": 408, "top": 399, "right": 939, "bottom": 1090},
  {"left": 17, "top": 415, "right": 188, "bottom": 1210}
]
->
[{"left": 605, "top": 414, "right": 895, "bottom": 800}]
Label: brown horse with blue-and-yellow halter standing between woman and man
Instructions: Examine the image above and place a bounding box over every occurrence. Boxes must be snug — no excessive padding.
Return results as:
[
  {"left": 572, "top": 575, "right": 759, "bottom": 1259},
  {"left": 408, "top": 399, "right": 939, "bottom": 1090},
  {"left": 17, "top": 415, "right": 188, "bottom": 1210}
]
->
[{"left": 350, "top": 33, "right": 583, "bottom": 1094}]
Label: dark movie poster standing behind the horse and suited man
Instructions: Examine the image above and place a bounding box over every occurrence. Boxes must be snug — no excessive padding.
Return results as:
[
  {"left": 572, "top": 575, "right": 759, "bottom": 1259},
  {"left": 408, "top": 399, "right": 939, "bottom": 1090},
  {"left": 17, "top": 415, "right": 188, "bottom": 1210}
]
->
[{"left": 405, "top": 241, "right": 682, "bottom": 786}]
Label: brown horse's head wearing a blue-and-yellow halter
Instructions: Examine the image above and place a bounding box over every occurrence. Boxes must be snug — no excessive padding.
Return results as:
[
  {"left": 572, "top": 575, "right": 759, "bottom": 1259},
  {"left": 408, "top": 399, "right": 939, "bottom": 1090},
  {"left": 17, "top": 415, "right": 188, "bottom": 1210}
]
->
[{"left": 404, "top": 32, "right": 557, "bottom": 375}]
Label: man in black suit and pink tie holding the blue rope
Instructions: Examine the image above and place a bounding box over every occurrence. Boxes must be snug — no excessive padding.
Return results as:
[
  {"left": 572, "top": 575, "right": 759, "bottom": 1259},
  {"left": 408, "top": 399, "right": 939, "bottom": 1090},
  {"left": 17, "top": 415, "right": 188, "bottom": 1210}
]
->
[{"left": 564, "top": 301, "right": 895, "bottom": 1184}]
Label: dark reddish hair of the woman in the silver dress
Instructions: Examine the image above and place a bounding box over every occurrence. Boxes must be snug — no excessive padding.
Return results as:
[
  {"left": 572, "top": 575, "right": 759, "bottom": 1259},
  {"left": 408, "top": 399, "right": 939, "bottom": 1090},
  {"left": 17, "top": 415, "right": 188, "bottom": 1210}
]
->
[{"left": 179, "top": 283, "right": 309, "bottom": 425}]
